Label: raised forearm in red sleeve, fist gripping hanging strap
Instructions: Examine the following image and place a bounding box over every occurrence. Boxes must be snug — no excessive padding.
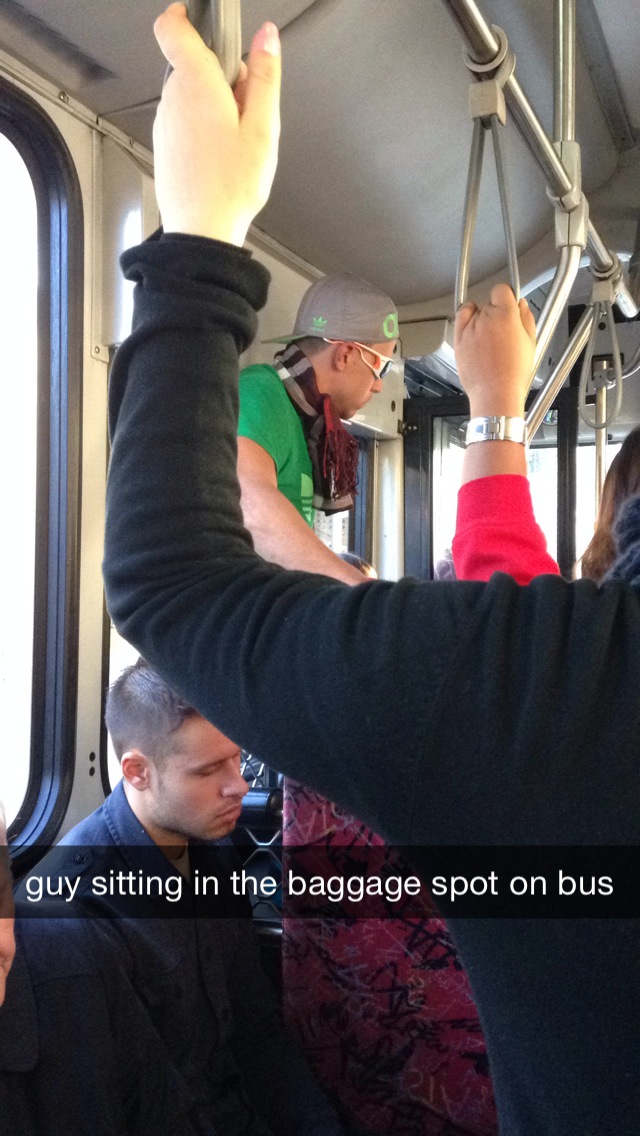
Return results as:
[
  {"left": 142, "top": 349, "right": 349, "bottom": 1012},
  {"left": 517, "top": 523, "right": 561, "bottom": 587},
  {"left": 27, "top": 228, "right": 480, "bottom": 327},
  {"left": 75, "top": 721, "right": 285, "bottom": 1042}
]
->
[{"left": 452, "top": 284, "right": 559, "bottom": 584}]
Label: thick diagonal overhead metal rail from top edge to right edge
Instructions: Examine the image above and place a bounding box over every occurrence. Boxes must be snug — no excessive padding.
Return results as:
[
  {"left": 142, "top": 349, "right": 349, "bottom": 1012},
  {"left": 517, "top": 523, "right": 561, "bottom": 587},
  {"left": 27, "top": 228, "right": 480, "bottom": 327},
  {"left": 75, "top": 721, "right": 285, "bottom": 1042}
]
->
[{"left": 442, "top": 0, "right": 640, "bottom": 319}]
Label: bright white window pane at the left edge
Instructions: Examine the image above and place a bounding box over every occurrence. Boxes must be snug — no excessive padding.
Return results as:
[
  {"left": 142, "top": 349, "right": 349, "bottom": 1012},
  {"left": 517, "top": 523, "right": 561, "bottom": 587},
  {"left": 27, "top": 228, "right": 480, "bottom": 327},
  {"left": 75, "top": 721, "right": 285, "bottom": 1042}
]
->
[{"left": 0, "top": 134, "right": 38, "bottom": 825}]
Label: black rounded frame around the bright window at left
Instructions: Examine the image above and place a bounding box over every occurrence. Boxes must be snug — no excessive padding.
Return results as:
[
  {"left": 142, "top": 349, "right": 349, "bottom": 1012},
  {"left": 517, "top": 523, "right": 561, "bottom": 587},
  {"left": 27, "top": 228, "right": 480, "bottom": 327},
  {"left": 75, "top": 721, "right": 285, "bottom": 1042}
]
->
[{"left": 0, "top": 77, "right": 84, "bottom": 868}]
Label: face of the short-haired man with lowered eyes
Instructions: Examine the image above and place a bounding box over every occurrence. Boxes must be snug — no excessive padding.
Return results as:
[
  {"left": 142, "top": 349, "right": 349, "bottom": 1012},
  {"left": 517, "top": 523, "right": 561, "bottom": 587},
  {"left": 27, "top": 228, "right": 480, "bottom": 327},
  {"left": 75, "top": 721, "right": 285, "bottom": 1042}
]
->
[{"left": 143, "top": 715, "right": 248, "bottom": 844}]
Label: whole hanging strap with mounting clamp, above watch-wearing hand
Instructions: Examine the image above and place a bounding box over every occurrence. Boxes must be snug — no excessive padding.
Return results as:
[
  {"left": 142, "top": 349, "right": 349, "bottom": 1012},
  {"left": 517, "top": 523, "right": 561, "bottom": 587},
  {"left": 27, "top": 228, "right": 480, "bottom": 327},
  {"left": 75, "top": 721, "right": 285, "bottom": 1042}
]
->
[{"left": 456, "top": 26, "right": 520, "bottom": 310}]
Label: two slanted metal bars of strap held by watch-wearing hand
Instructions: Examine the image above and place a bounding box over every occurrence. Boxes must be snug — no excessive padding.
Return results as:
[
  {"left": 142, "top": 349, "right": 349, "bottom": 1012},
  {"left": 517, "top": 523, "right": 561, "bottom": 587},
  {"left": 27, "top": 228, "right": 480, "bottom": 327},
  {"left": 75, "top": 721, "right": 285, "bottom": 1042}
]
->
[{"left": 456, "top": 115, "right": 520, "bottom": 311}]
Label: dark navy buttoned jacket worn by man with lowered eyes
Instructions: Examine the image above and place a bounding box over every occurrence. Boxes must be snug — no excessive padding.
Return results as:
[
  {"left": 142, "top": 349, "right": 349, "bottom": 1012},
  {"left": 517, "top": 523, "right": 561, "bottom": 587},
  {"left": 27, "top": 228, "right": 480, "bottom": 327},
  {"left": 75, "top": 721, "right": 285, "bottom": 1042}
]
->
[{"left": 6, "top": 782, "right": 342, "bottom": 1136}]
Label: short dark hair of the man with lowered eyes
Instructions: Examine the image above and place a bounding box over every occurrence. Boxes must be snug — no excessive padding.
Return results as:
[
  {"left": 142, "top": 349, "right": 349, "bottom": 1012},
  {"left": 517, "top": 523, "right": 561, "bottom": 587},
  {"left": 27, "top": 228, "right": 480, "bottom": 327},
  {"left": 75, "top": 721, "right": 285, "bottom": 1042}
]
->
[{"left": 105, "top": 659, "right": 198, "bottom": 761}]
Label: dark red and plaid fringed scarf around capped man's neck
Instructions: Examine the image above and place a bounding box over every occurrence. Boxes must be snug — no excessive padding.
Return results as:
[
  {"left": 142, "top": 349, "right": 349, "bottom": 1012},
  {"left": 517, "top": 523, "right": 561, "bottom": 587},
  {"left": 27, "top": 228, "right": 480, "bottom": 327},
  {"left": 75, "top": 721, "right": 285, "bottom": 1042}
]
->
[{"left": 274, "top": 343, "right": 358, "bottom": 512}]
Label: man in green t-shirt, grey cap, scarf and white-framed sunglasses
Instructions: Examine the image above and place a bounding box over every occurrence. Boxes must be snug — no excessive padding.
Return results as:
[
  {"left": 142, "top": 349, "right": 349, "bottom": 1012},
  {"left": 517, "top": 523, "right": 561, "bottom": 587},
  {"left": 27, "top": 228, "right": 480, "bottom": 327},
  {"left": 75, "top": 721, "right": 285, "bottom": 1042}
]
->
[{"left": 238, "top": 273, "right": 398, "bottom": 584}]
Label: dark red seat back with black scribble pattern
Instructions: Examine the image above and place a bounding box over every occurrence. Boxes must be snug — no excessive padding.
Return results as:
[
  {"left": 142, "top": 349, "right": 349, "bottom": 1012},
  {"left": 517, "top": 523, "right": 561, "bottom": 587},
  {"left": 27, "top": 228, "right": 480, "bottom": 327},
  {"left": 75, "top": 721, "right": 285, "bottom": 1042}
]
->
[{"left": 283, "top": 782, "right": 498, "bottom": 1136}]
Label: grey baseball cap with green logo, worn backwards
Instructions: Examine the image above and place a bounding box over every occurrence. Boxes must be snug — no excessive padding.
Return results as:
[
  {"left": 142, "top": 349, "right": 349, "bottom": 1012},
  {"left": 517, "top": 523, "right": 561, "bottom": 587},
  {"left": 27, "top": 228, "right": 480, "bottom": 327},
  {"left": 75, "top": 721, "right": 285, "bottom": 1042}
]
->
[{"left": 263, "top": 273, "right": 398, "bottom": 343}]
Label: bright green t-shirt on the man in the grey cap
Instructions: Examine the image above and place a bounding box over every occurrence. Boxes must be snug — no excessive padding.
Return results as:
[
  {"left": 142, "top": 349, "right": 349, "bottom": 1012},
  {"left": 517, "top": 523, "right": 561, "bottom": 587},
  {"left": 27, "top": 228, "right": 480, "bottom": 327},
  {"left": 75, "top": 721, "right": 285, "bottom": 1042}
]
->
[{"left": 238, "top": 364, "right": 315, "bottom": 527}]
